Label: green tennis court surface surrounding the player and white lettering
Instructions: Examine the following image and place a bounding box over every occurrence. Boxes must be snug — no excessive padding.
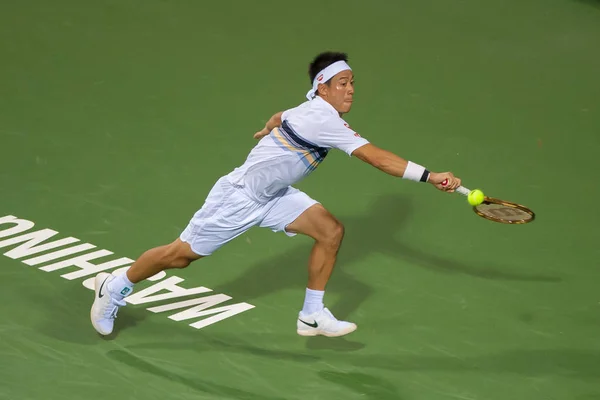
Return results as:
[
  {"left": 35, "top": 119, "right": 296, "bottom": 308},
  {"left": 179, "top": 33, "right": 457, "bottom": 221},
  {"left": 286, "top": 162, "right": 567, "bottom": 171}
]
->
[{"left": 0, "top": 0, "right": 600, "bottom": 400}]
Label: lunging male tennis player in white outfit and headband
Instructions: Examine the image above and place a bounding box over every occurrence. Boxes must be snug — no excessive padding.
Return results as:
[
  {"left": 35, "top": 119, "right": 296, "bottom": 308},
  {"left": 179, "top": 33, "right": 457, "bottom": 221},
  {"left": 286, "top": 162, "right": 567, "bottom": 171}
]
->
[{"left": 91, "top": 52, "right": 461, "bottom": 336}]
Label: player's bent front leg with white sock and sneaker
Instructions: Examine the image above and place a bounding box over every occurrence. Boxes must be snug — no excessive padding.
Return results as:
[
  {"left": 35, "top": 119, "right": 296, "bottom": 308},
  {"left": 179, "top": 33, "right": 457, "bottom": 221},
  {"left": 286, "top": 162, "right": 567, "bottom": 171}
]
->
[{"left": 286, "top": 204, "right": 356, "bottom": 336}]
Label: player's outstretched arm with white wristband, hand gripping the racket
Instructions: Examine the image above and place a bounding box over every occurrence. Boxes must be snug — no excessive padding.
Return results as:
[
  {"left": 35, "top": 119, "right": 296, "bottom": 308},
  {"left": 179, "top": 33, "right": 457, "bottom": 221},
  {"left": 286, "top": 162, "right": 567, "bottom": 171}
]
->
[{"left": 352, "top": 143, "right": 461, "bottom": 192}]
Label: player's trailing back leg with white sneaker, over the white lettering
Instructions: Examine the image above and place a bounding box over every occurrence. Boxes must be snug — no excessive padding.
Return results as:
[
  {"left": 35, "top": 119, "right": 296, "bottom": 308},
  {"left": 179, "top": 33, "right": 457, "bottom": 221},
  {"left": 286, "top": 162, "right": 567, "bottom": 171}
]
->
[{"left": 90, "top": 239, "right": 201, "bottom": 335}]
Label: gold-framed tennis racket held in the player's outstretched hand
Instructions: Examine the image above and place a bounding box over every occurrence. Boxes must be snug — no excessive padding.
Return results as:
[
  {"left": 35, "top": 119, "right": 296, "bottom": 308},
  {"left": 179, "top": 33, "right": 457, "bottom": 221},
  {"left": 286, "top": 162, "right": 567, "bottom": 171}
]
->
[{"left": 442, "top": 180, "right": 535, "bottom": 224}]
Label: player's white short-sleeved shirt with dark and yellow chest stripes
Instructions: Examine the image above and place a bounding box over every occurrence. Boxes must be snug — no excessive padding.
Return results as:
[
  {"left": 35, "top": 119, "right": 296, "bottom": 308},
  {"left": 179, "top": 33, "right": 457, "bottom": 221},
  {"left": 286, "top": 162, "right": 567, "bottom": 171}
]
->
[{"left": 227, "top": 96, "right": 369, "bottom": 203}]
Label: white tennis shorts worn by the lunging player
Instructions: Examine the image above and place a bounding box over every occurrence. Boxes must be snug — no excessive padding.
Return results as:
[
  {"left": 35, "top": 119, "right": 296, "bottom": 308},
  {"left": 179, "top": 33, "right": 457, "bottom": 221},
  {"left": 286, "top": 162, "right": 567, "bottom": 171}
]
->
[{"left": 180, "top": 177, "right": 318, "bottom": 256}]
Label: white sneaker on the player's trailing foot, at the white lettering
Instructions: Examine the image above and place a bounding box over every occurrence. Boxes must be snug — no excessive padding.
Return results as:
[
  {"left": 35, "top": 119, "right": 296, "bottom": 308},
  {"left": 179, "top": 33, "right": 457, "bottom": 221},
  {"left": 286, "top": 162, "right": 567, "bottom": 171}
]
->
[{"left": 90, "top": 272, "right": 125, "bottom": 335}]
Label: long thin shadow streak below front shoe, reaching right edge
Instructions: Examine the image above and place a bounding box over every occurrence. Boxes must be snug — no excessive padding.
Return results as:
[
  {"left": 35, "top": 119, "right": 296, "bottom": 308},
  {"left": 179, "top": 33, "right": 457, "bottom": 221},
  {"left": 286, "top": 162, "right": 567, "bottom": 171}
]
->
[{"left": 119, "top": 334, "right": 600, "bottom": 384}]
